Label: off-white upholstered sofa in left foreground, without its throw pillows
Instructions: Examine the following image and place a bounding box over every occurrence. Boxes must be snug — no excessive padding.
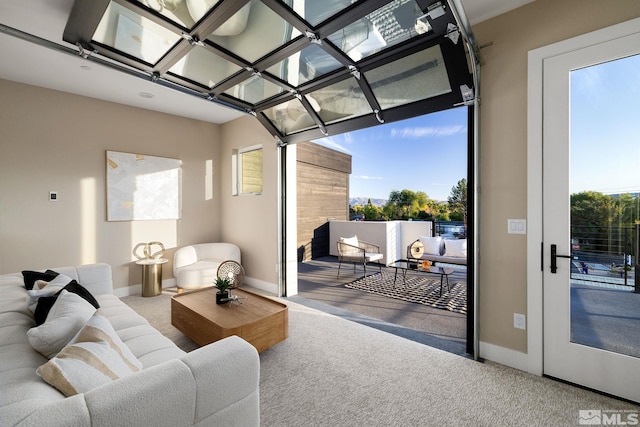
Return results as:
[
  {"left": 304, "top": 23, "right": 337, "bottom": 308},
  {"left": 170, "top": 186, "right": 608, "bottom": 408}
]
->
[{"left": 0, "top": 264, "right": 260, "bottom": 427}]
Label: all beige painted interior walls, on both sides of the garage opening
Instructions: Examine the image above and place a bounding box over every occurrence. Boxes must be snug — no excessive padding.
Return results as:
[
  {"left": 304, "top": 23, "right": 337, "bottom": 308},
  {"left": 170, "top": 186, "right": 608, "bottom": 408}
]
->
[{"left": 0, "top": 0, "right": 640, "bottom": 362}]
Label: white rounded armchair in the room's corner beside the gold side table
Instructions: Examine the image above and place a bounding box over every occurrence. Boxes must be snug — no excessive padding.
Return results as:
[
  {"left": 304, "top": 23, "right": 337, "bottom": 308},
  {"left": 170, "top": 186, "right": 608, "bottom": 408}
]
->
[{"left": 173, "top": 243, "right": 242, "bottom": 291}]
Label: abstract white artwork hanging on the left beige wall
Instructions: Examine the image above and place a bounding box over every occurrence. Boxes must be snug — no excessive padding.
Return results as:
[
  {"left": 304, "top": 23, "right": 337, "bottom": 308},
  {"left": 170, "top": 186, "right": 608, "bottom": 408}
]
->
[{"left": 106, "top": 151, "right": 182, "bottom": 221}]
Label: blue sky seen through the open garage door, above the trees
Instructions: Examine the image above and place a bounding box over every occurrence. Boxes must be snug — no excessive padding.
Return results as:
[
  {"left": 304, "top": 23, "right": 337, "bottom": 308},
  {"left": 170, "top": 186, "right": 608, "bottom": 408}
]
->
[{"left": 313, "top": 107, "right": 467, "bottom": 201}]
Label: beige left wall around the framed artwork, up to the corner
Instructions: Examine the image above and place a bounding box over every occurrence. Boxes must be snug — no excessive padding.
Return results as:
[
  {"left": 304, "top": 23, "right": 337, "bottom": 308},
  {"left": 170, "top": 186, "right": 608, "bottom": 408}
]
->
[{"left": 0, "top": 80, "right": 222, "bottom": 287}]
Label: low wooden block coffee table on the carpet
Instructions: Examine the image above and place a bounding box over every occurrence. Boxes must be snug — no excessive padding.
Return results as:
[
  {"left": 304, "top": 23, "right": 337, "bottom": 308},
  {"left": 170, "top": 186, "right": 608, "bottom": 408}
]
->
[{"left": 171, "top": 287, "right": 289, "bottom": 352}]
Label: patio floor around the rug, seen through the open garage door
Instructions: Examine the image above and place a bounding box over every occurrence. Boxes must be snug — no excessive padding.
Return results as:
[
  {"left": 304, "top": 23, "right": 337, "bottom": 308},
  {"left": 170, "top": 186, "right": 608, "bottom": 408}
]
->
[{"left": 291, "top": 256, "right": 466, "bottom": 355}]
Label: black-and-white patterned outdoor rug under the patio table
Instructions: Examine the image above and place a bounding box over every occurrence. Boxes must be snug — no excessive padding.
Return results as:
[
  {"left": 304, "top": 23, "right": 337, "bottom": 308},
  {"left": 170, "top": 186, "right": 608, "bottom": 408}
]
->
[{"left": 345, "top": 271, "right": 467, "bottom": 314}]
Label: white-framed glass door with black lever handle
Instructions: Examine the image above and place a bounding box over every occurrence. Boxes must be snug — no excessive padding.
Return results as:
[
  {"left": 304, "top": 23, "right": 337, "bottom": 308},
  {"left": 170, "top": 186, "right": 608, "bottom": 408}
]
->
[{"left": 543, "top": 34, "right": 640, "bottom": 401}]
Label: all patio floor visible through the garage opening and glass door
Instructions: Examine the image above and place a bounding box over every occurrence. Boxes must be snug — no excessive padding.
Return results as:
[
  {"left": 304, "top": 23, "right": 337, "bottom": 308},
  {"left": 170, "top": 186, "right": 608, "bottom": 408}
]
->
[{"left": 290, "top": 256, "right": 640, "bottom": 357}]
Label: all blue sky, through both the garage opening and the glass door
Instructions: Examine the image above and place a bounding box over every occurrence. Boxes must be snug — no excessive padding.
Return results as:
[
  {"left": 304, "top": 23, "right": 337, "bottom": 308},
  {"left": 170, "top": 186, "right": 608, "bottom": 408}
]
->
[{"left": 314, "top": 51, "right": 640, "bottom": 205}]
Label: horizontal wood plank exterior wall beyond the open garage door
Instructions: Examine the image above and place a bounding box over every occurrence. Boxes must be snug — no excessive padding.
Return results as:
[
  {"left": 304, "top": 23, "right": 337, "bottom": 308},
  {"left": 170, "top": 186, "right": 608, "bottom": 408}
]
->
[{"left": 296, "top": 142, "right": 351, "bottom": 261}]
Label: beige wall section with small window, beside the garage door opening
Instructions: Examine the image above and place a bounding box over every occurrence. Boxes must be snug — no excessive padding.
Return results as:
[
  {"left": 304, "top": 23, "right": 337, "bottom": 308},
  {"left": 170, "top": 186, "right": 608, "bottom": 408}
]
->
[{"left": 221, "top": 116, "right": 278, "bottom": 293}]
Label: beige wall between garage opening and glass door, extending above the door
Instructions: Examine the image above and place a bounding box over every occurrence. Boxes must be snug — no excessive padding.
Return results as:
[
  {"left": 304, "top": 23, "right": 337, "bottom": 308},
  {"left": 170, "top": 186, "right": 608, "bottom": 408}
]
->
[{"left": 473, "top": 0, "right": 640, "bottom": 352}]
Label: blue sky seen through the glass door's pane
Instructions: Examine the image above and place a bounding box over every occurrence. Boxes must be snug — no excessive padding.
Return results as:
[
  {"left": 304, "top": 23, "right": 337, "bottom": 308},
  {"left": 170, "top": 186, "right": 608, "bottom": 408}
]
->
[{"left": 570, "top": 51, "right": 640, "bottom": 194}]
